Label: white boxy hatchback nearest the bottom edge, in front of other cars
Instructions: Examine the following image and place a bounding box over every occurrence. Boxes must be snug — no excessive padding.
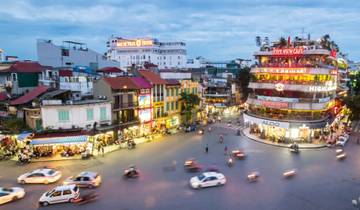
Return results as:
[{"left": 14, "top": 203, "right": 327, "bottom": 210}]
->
[{"left": 39, "top": 184, "right": 80, "bottom": 206}]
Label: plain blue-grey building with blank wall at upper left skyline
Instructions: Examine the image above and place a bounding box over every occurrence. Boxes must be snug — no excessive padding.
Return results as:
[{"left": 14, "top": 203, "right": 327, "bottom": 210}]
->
[{"left": 36, "top": 39, "right": 119, "bottom": 70}]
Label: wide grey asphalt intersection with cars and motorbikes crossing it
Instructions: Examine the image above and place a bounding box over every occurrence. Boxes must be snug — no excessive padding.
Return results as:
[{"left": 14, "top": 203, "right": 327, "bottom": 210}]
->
[{"left": 0, "top": 120, "right": 360, "bottom": 210}]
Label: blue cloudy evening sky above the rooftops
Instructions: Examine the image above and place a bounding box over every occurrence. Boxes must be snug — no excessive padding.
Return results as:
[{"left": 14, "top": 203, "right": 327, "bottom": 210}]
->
[{"left": 0, "top": 0, "right": 360, "bottom": 61}]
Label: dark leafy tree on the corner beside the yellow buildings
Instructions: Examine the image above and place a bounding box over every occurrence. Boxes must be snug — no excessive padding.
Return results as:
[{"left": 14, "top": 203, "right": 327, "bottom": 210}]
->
[{"left": 180, "top": 92, "right": 200, "bottom": 123}]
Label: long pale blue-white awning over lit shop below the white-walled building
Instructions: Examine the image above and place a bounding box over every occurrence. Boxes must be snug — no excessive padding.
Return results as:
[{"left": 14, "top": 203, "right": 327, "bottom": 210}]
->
[{"left": 31, "top": 135, "right": 88, "bottom": 145}]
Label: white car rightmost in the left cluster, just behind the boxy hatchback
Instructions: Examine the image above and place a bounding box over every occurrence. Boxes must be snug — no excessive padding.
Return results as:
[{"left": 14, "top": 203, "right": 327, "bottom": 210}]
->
[{"left": 63, "top": 171, "right": 101, "bottom": 188}]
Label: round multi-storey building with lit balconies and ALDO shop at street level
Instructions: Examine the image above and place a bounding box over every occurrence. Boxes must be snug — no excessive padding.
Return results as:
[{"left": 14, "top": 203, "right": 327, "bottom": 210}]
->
[{"left": 244, "top": 39, "right": 340, "bottom": 142}]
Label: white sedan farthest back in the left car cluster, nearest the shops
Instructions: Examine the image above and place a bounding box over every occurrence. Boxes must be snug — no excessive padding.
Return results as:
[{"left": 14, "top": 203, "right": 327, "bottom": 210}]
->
[{"left": 17, "top": 168, "right": 61, "bottom": 184}]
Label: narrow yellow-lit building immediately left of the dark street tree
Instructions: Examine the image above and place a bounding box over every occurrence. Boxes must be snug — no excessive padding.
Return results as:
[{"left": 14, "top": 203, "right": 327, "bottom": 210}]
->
[{"left": 165, "top": 80, "right": 181, "bottom": 129}]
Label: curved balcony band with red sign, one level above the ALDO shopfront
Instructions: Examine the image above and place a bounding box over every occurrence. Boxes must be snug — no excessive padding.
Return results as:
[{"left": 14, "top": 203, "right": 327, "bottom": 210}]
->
[{"left": 246, "top": 98, "right": 329, "bottom": 110}]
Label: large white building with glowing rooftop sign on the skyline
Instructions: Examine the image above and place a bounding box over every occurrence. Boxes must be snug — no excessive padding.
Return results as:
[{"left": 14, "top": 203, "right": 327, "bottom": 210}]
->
[{"left": 107, "top": 37, "right": 187, "bottom": 69}]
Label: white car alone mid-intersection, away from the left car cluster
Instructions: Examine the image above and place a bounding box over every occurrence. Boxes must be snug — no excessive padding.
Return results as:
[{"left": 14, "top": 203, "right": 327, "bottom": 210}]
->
[{"left": 190, "top": 172, "right": 226, "bottom": 189}]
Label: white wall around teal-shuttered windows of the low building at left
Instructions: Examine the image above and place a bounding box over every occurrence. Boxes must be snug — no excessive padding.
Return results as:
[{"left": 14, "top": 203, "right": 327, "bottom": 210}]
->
[{"left": 41, "top": 102, "right": 112, "bottom": 129}]
